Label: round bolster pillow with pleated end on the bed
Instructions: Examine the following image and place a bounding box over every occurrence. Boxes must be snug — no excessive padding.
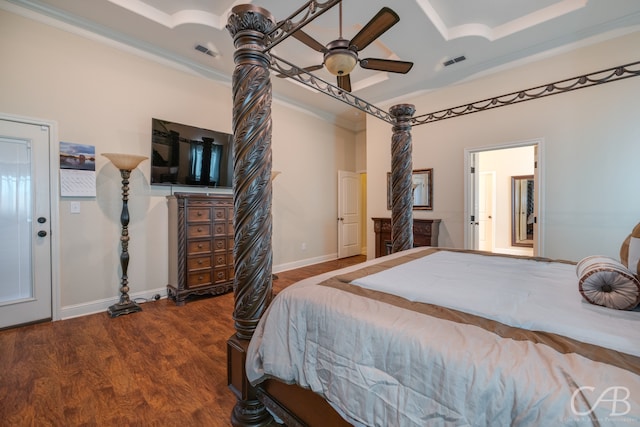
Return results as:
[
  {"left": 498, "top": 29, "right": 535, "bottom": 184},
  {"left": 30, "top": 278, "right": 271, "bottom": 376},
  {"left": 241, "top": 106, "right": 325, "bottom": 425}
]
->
[{"left": 576, "top": 255, "right": 640, "bottom": 310}]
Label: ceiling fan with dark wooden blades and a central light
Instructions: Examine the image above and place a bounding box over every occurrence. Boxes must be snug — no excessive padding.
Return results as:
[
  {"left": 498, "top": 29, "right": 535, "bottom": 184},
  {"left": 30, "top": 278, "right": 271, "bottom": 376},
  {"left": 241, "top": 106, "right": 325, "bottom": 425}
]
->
[{"left": 278, "top": 2, "right": 413, "bottom": 92}]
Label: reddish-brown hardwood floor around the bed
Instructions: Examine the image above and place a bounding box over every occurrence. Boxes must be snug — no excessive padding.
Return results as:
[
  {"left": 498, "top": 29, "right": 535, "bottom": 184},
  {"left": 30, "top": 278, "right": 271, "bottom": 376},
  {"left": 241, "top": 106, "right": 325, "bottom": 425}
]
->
[{"left": 0, "top": 256, "right": 365, "bottom": 427}]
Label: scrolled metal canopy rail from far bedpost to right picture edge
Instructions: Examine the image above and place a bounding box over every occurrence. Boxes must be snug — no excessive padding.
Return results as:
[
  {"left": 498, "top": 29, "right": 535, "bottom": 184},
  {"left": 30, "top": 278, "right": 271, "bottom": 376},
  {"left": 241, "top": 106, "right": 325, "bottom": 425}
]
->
[{"left": 412, "top": 61, "right": 640, "bottom": 126}]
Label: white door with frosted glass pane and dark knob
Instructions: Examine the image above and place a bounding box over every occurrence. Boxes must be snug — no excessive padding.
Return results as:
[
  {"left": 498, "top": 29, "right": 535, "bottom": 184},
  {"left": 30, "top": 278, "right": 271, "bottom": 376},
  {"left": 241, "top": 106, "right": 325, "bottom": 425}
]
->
[{"left": 0, "top": 119, "right": 52, "bottom": 328}]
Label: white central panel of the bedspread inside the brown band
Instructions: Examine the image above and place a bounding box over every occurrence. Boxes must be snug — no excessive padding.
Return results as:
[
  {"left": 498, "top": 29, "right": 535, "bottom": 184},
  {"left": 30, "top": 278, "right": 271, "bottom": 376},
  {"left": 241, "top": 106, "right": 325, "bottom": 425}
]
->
[{"left": 353, "top": 251, "right": 640, "bottom": 356}]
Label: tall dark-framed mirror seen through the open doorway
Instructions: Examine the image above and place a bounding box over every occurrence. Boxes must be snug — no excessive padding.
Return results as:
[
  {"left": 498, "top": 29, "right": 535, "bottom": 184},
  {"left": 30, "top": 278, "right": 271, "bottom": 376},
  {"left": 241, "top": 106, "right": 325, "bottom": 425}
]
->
[{"left": 511, "top": 175, "right": 535, "bottom": 248}]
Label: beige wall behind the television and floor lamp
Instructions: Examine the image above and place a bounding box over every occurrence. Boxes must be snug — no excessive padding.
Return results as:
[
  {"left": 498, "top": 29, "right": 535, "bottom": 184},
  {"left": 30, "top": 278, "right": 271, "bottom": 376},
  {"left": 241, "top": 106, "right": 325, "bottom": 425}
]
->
[{"left": 0, "top": 10, "right": 356, "bottom": 317}]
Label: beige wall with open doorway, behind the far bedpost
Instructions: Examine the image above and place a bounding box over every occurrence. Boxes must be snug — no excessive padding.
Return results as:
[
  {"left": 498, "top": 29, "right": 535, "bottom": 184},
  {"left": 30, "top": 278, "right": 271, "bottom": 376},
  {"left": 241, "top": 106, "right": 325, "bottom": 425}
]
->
[{"left": 367, "top": 32, "right": 640, "bottom": 260}]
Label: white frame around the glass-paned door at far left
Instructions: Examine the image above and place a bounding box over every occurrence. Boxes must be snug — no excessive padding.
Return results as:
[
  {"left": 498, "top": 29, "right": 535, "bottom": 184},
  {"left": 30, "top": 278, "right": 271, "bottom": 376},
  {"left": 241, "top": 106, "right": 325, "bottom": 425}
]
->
[{"left": 0, "top": 112, "right": 60, "bottom": 321}]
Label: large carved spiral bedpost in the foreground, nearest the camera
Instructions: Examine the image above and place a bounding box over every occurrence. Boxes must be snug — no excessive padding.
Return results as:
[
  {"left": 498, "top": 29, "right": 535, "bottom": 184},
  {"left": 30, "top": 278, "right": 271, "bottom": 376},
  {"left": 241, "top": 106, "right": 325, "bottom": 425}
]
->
[{"left": 227, "top": 4, "right": 275, "bottom": 426}]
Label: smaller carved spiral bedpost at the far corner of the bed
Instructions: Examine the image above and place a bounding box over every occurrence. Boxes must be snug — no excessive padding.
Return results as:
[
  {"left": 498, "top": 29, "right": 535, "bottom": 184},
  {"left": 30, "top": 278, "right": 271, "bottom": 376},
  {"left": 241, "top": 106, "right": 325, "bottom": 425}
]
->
[{"left": 389, "top": 104, "right": 416, "bottom": 252}]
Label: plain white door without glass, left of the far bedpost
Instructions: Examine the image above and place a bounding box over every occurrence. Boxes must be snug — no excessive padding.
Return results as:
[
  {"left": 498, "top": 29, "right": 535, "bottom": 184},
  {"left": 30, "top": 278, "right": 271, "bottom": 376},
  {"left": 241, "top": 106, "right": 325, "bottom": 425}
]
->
[{"left": 338, "top": 171, "right": 361, "bottom": 258}]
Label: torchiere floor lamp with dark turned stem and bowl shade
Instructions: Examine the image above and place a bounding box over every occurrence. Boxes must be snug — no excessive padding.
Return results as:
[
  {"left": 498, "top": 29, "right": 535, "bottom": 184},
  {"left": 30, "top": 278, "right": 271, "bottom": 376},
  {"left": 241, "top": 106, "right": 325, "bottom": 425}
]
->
[{"left": 102, "top": 153, "right": 148, "bottom": 317}]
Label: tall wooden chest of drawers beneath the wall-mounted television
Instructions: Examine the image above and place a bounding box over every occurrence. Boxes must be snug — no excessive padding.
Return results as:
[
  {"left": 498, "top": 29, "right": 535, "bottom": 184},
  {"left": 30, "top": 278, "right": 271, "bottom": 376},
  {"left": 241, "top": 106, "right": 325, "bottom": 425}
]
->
[{"left": 167, "top": 193, "right": 234, "bottom": 305}]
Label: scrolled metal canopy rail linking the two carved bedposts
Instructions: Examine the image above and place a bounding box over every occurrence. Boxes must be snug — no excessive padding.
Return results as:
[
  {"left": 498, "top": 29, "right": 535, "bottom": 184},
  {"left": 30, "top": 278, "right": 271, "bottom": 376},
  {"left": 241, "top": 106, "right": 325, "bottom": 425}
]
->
[{"left": 269, "top": 54, "right": 395, "bottom": 125}]
